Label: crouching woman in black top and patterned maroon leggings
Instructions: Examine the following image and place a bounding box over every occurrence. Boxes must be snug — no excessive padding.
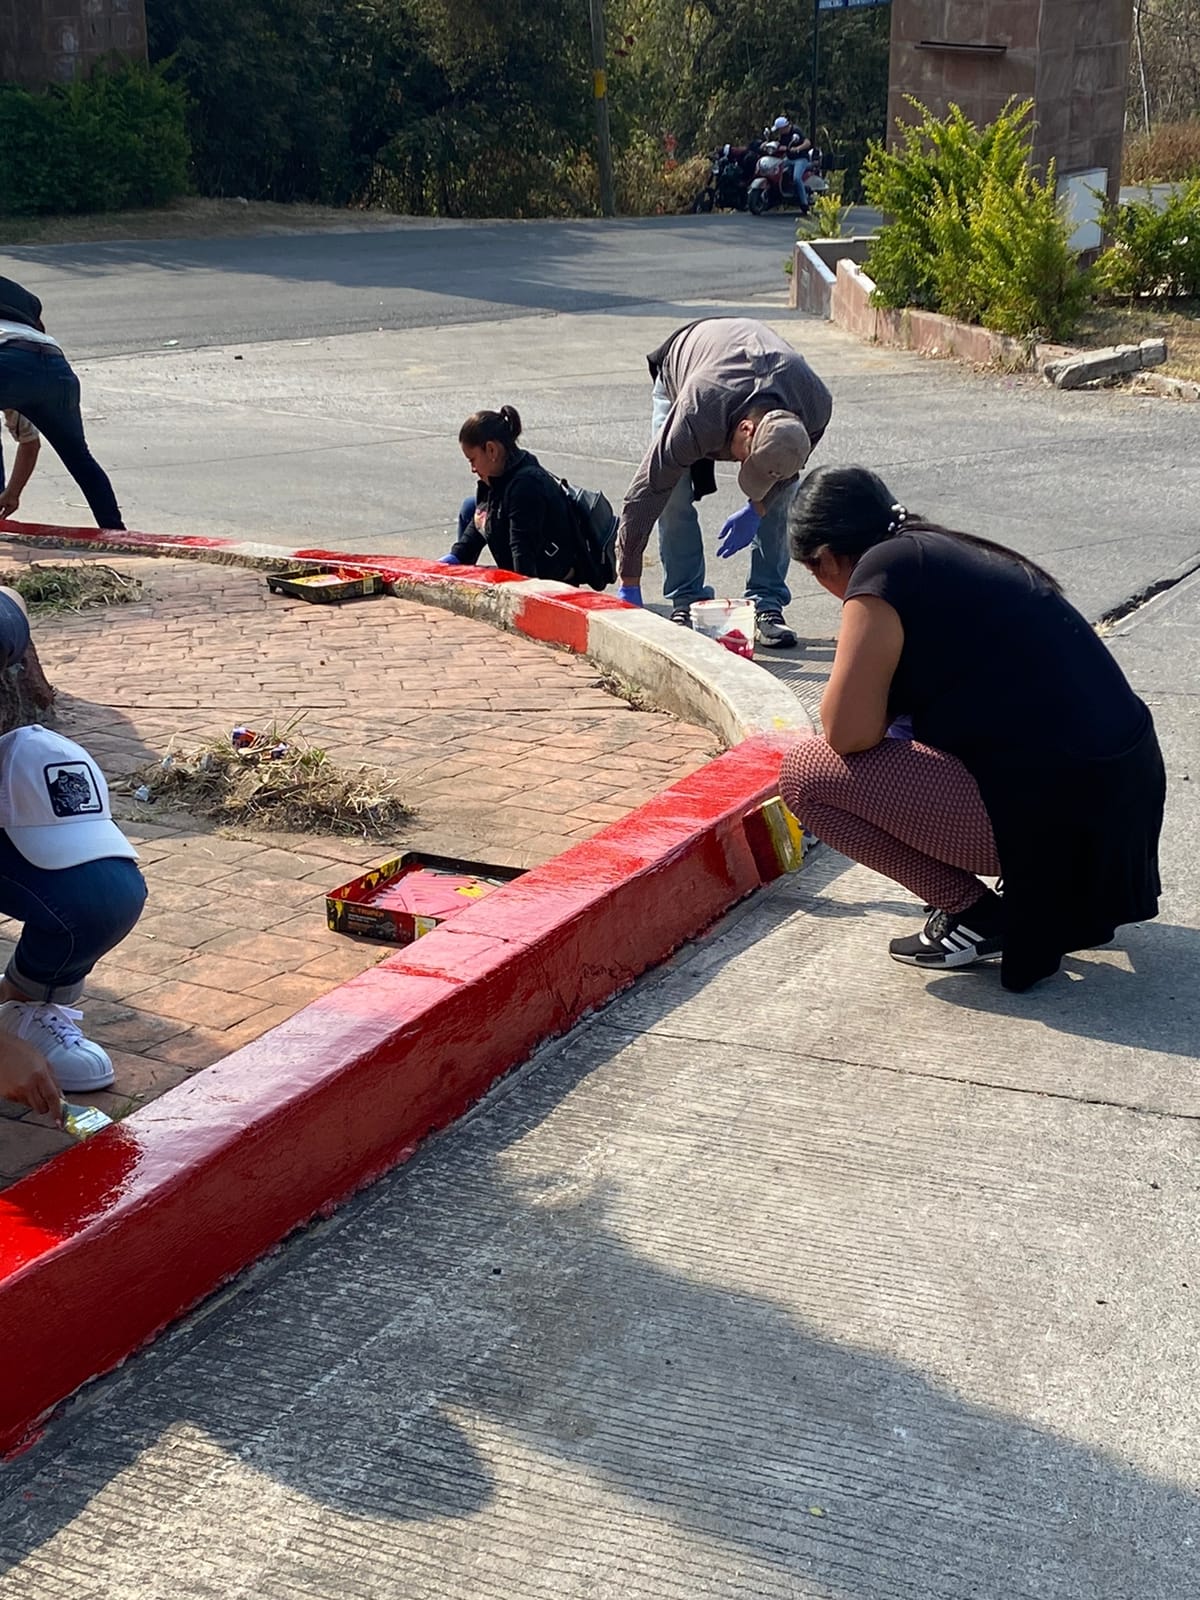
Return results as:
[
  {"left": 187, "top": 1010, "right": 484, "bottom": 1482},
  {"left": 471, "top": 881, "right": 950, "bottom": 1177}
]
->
[{"left": 779, "top": 467, "right": 1166, "bottom": 990}]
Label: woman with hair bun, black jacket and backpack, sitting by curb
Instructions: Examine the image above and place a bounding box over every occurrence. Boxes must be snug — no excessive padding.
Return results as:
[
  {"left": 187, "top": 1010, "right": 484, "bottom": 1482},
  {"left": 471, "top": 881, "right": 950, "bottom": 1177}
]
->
[{"left": 442, "top": 405, "right": 582, "bottom": 584}]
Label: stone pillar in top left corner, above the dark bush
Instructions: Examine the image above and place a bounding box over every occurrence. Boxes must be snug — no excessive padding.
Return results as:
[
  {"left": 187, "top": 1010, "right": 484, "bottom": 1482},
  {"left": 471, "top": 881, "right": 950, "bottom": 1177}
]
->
[{"left": 0, "top": 0, "right": 146, "bottom": 88}]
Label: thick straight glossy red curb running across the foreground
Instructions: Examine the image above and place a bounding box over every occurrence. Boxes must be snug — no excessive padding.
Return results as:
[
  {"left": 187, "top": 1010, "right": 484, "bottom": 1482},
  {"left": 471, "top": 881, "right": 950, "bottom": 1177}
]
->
[{"left": 0, "top": 732, "right": 800, "bottom": 1451}]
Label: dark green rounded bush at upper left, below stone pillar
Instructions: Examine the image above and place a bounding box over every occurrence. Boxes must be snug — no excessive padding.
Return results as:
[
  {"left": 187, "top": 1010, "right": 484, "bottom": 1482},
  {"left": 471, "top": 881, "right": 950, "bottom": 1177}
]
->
[{"left": 0, "top": 62, "right": 189, "bottom": 216}]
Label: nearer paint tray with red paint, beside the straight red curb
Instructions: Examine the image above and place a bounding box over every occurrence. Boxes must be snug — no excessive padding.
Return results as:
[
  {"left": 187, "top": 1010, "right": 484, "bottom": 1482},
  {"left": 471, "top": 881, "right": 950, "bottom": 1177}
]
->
[{"left": 325, "top": 850, "right": 520, "bottom": 944}]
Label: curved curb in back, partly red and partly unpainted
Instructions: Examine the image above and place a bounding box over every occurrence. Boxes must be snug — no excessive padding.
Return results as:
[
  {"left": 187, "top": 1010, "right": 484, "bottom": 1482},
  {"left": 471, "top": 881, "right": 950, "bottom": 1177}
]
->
[{"left": 0, "top": 520, "right": 813, "bottom": 744}]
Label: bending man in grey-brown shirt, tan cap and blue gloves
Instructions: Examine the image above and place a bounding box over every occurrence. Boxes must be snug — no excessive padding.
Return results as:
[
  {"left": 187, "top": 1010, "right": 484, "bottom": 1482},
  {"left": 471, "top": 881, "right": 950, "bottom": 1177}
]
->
[{"left": 616, "top": 317, "right": 834, "bottom": 648}]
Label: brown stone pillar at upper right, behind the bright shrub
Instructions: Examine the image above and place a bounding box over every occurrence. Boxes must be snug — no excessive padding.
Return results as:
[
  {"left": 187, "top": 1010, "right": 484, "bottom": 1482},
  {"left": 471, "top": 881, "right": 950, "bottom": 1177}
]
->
[{"left": 888, "top": 0, "right": 1133, "bottom": 198}]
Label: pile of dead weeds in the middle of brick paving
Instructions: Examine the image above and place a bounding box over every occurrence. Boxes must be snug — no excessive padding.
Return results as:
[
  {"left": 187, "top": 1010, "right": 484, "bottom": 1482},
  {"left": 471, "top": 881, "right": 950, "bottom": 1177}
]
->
[{"left": 120, "top": 718, "right": 414, "bottom": 840}]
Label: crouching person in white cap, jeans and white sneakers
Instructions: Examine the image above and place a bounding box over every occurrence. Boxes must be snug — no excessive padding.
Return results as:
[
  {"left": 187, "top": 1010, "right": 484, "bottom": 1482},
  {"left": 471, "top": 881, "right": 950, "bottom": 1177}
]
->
[{"left": 0, "top": 720, "right": 146, "bottom": 1104}]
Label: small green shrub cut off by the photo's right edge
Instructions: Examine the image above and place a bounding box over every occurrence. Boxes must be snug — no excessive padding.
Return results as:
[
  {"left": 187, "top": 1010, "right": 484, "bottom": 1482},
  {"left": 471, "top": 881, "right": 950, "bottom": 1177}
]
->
[{"left": 1096, "top": 178, "right": 1200, "bottom": 299}]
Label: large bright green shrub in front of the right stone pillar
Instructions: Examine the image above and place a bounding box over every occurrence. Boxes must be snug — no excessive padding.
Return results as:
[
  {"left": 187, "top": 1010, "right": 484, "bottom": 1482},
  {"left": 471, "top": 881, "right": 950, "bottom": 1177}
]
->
[{"left": 864, "top": 101, "right": 1088, "bottom": 338}]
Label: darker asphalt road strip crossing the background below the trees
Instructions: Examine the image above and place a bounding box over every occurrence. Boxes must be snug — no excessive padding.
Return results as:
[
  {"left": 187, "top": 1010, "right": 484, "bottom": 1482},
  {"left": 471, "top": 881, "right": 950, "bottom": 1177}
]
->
[{"left": 0, "top": 213, "right": 809, "bottom": 360}]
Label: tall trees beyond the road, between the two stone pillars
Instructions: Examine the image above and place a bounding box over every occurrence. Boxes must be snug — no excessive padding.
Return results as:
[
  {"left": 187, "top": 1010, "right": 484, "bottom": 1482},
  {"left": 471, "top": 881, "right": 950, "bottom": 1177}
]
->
[{"left": 147, "top": 0, "right": 888, "bottom": 216}]
